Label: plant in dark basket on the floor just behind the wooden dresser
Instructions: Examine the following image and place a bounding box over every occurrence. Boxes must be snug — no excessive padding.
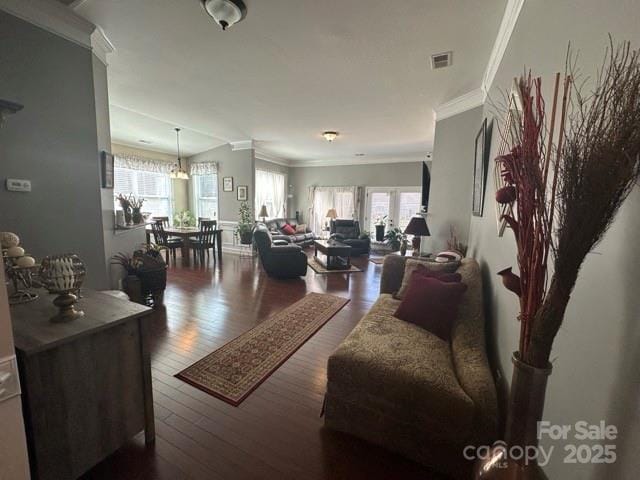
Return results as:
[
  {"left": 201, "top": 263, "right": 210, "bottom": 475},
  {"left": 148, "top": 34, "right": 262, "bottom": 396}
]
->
[{"left": 111, "top": 243, "right": 167, "bottom": 308}]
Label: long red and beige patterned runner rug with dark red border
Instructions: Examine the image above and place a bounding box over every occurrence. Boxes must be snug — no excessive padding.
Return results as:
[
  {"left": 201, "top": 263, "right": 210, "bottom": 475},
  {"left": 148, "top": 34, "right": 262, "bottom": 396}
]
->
[{"left": 176, "top": 293, "right": 349, "bottom": 406}]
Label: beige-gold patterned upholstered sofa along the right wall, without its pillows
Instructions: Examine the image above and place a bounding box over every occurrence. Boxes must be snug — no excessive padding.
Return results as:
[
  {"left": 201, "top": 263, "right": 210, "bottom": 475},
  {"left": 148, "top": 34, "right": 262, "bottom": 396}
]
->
[{"left": 325, "top": 255, "right": 497, "bottom": 478}]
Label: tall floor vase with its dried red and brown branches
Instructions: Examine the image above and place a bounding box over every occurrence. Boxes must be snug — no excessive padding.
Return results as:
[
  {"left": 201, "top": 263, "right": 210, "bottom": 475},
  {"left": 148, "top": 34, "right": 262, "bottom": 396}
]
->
[{"left": 476, "top": 42, "right": 640, "bottom": 479}]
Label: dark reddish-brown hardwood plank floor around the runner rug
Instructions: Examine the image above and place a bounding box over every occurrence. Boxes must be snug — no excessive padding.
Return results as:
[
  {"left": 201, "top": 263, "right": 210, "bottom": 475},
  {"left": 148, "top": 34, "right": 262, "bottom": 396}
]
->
[{"left": 86, "top": 251, "right": 436, "bottom": 480}]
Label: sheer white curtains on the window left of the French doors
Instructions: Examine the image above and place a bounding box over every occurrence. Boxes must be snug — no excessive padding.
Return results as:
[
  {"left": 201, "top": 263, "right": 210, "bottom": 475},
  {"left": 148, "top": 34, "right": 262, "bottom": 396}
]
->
[{"left": 309, "top": 186, "right": 361, "bottom": 235}]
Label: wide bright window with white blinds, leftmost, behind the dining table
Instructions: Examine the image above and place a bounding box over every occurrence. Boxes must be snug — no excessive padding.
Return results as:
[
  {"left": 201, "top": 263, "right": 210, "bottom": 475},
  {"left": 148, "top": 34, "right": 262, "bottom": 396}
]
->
[{"left": 113, "top": 167, "right": 172, "bottom": 217}]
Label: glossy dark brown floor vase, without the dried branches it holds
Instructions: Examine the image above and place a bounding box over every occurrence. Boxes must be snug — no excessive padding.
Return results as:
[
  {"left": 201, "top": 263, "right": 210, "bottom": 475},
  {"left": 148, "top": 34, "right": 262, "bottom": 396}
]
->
[{"left": 474, "top": 352, "right": 551, "bottom": 480}]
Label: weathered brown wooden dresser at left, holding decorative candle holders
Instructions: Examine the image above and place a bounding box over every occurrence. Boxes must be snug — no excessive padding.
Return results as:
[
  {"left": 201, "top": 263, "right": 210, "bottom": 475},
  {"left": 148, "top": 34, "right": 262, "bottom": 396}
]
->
[{"left": 11, "top": 290, "right": 155, "bottom": 480}]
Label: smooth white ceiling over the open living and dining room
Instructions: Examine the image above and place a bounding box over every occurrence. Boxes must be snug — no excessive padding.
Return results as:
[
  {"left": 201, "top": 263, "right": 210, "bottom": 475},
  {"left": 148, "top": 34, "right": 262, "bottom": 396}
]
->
[{"left": 75, "top": 0, "right": 506, "bottom": 163}]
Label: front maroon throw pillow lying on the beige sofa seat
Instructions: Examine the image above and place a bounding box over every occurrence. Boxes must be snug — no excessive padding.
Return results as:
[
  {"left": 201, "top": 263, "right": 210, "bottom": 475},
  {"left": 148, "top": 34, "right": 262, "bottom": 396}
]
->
[{"left": 394, "top": 275, "right": 467, "bottom": 342}]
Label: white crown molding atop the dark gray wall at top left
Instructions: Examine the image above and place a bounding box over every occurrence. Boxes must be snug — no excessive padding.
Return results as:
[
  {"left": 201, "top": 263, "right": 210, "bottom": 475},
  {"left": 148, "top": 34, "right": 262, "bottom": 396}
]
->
[{"left": 0, "top": 0, "right": 95, "bottom": 49}]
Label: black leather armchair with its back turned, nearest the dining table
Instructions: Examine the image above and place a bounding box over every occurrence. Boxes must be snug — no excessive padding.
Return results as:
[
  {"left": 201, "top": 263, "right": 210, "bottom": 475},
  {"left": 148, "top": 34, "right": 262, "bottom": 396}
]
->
[{"left": 253, "top": 223, "right": 307, "bottom": 278}]
